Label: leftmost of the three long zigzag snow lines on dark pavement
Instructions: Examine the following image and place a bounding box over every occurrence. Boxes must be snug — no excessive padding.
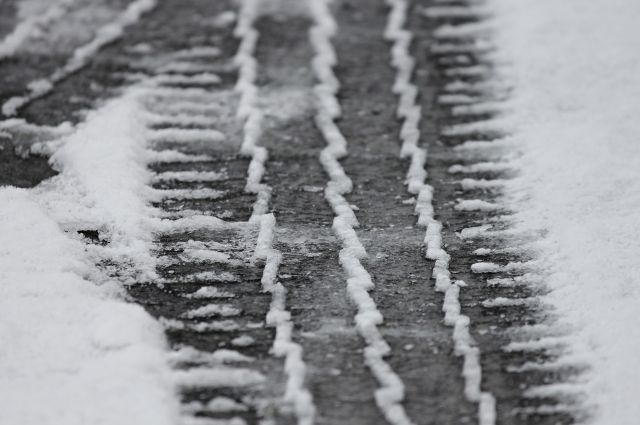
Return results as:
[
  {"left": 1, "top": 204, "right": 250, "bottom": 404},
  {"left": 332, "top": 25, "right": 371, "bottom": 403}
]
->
[{"left": 234, "top": 0, "right": 315, "bottom": 425}]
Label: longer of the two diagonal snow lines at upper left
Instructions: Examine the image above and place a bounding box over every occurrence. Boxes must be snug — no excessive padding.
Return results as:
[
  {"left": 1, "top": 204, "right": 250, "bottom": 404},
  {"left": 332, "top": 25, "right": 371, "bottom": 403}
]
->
[{"left": 2, "top": 0, "right": 157, "bottom": 116}]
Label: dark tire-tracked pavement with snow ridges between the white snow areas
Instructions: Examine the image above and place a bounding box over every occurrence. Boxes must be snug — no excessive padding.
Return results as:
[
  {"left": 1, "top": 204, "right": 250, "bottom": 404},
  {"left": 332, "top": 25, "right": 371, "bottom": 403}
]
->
[{"left": 0, "top": 0, "right": 580, "bottom": 425}]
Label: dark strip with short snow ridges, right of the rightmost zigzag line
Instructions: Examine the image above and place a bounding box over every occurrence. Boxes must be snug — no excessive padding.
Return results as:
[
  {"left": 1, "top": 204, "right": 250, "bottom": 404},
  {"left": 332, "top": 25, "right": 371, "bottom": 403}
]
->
[{"left": 413, "top": 1, "right": 582, "bottom": 424}]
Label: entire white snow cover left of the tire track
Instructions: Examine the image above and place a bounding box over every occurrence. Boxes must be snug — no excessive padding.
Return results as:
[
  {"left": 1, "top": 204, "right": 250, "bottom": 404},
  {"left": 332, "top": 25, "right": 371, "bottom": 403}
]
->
[{"left": 0, "top": 95, "right": 179, "bottom": 425}]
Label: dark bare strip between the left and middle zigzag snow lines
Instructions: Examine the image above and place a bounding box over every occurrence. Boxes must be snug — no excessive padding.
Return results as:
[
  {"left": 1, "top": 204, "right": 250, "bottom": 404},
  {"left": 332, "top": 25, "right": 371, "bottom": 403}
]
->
[{"left": 256, "top": 5, "right": 384, "bottom": 424}]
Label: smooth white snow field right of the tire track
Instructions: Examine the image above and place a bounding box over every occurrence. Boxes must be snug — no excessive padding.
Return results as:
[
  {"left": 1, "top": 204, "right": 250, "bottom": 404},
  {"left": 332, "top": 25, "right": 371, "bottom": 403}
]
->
[{"left": 491, "top": 0, "right": 640, "bottom": 425}]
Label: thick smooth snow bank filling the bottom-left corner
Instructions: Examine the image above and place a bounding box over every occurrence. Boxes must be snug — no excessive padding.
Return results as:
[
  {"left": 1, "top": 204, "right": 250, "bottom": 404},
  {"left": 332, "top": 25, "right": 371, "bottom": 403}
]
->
[{"left": 0, "top": 188, "right": 179, "bottom": 425}]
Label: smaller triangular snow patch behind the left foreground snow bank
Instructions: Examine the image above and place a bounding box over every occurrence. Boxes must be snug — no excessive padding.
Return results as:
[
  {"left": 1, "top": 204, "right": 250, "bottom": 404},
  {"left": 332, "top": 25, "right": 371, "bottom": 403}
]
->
[{"left": 36, "top": 92, "right": 156, "bottom": 277}]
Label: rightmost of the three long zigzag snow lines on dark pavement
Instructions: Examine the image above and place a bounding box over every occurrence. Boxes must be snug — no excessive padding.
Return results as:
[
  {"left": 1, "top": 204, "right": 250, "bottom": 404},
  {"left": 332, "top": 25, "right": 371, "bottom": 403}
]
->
[{"left": 384, "top": 0, "right": 496, "bottom": 425}]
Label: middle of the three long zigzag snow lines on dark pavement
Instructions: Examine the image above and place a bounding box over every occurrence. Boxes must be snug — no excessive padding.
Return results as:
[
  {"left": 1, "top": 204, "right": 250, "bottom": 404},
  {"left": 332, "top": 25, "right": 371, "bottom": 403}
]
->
[{"left": 309, "top": 0, "right": 413, "bottom": 425}]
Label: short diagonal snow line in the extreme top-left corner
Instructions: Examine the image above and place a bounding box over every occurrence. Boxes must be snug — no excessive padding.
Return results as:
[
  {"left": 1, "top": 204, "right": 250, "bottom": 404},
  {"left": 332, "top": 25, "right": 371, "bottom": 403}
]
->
[{"left": 0, "top": 0, "right": 77, "bottom": 60}]
